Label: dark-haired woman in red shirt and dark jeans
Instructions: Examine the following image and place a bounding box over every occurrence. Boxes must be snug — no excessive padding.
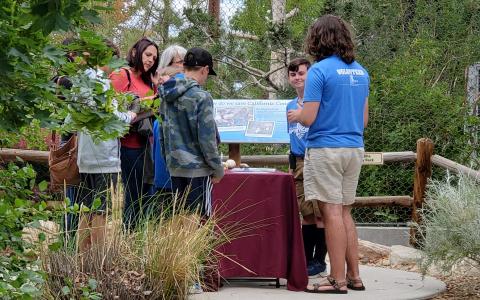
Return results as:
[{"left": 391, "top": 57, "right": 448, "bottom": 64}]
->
[{"left": 110, "top": 37, "right": 159, "bottom": 229}]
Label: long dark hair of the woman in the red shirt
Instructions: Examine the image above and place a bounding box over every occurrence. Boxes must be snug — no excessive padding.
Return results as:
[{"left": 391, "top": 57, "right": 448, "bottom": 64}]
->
[{"left": 127, "top": 37, "right": 159, "bottom": 86}]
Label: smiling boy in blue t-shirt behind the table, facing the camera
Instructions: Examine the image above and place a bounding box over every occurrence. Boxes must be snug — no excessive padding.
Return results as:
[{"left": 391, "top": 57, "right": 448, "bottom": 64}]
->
[{"left": 287, "top": 58, "right": 327, "bottom": 278}]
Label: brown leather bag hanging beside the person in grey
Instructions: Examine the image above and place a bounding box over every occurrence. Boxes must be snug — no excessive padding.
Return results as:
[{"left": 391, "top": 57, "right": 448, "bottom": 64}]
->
[{"left": 48, "top": 133, "right": 80, "bottom": 191}]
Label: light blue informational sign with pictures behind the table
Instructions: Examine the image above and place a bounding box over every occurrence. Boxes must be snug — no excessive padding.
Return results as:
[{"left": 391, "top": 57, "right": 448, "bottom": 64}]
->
[{"left": 213, "top": 99, "right": 290, "bottom": 144}]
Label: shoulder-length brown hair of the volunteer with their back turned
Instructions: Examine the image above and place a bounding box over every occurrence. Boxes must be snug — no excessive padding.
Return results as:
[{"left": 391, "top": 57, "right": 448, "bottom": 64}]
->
[{"left": 305, "top": 15, "right": 355, "bottom": 64}]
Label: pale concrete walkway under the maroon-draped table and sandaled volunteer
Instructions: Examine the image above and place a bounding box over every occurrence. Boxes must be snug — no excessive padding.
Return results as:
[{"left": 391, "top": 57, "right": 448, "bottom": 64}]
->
[{"left": 189, "top": 266, "right": 446, "bottom": 300}]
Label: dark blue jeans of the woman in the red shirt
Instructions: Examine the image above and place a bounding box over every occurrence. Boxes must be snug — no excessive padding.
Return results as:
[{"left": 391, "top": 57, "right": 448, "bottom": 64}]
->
[{"left": 120, "top": 147, "right": 152, "bottom": 230}]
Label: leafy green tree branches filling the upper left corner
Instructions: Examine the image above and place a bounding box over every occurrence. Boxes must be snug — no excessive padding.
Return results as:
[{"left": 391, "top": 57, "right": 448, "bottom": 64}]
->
[{"left": 0, "top": 0, "right": 131, "bottom": 138}]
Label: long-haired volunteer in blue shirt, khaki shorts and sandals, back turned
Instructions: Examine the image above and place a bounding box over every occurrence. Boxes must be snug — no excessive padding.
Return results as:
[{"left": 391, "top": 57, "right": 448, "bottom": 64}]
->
[{"left": 288, "top": 15, "right": 369, "bottom": 294}]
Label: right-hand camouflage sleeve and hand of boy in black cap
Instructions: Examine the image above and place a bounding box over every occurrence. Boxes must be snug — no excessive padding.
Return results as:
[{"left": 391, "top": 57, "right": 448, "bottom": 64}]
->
[{"left": 194, "top": 93, "right": 224, "bottom": 183}]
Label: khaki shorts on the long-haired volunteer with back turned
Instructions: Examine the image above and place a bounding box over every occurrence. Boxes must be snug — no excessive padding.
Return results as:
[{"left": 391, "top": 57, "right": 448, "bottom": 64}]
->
[{"left": 303, "top": 148, "right": 364, "bottom": 205}]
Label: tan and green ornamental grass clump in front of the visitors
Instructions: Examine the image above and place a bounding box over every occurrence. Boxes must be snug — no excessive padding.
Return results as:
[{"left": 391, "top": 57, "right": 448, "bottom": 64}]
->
[{"left": 43, "top": 188, "right": 232, "bottom": 299}]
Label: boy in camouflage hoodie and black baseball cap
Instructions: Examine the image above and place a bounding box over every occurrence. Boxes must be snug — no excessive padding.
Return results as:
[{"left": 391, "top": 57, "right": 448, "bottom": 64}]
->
[{"left": 159, "top": 48, "right": 223, "bottom": 215}]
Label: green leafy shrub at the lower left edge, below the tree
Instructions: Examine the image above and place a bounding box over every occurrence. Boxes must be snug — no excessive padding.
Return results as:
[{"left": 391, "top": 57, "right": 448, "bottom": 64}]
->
[{"left": 0, "top": 163, "right": 49, "bottom": 299}]
